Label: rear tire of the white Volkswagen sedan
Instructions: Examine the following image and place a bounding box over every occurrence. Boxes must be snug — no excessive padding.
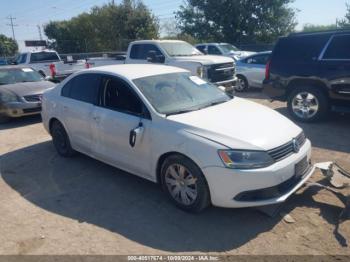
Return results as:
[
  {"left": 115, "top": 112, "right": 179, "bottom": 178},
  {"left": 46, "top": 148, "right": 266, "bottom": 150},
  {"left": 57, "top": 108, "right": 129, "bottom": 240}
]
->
[{"left": 51, "top": 121, "right": 76, "bottom": 157}]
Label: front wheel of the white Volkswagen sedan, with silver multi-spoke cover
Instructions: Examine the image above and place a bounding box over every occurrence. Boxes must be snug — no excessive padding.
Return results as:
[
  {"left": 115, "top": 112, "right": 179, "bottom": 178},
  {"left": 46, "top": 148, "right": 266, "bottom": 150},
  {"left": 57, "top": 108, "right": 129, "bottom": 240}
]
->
[{"left": 161, "top": 155, "right": 210, "bottom": 213}]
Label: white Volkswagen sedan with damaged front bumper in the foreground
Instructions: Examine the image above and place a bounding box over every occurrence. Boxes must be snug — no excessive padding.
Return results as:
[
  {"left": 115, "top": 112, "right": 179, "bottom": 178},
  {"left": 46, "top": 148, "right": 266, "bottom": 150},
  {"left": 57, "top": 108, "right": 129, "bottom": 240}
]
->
[{"left": 42, "top": 65, "right": 314, "bottom": 212}]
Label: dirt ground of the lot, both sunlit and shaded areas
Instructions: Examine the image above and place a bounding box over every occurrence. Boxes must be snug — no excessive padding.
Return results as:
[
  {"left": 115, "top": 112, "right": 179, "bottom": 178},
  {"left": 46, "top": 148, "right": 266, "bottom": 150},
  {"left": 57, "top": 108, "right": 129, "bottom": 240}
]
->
[{"left": 0, "top": 92, "right": 350, "bottom": 255}]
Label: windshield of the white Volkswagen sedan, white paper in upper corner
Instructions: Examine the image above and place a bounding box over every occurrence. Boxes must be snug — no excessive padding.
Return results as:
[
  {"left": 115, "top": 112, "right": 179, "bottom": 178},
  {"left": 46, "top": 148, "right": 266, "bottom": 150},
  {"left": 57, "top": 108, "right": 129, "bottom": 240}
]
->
[{"left": 134, "top": 73, "right": 232, "bottom": 115}]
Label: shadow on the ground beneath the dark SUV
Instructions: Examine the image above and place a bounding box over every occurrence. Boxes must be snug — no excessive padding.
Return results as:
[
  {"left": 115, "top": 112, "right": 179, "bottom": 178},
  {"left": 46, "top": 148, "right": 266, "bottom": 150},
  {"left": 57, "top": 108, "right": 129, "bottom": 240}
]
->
[{"left": 276, "top": 107, "right": 350, "bottom": 153}]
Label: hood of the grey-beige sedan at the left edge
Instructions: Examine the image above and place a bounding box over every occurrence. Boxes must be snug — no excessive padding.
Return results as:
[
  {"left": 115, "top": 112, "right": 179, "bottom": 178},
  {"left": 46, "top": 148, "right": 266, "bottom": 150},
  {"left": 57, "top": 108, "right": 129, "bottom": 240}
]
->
[{"left": 0, "top": 81, "right": 55, "bottom": 97}]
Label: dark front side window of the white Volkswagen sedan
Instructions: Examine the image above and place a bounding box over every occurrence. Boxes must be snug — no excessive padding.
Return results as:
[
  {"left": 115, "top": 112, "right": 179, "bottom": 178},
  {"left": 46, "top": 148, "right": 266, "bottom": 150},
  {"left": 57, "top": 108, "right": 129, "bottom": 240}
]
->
[{"left": 100, "top": 77, "right": 143, "bottom": 115}]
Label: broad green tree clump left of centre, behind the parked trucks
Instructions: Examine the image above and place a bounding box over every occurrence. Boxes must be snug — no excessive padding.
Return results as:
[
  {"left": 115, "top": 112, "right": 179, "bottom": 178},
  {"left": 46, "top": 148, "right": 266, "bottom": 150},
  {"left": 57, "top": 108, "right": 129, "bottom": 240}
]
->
[{"left": 44, "top": 0, "right": 159, "bottom": 53}]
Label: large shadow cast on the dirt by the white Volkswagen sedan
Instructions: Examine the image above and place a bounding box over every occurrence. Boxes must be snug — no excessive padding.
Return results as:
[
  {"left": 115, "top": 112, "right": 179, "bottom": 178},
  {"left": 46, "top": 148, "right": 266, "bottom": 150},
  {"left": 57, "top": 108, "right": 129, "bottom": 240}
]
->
[{"left": 0, "top": 142, "right": 344, "bottom": 252}]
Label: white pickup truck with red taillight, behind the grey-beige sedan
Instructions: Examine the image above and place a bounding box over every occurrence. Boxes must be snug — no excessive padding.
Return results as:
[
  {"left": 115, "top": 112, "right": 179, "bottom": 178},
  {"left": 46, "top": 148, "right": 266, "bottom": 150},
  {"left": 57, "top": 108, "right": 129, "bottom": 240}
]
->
[{"left": 15, "top": 50, "right": 86, "bottom": 81}]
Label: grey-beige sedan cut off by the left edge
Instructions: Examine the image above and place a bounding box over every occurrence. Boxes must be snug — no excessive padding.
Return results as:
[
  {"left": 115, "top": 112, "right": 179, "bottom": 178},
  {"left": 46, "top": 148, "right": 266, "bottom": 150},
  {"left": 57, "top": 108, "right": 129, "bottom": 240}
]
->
[{"left": 0, "top": 66, "right": 55, "bottom": 123}]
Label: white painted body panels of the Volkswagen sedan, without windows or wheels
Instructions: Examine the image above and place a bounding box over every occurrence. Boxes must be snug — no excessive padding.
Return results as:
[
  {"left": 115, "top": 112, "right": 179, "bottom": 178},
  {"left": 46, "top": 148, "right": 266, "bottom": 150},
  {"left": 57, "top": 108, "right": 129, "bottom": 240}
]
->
[{"left": 42, "top": 65, "right": 314, "bottom": 208}]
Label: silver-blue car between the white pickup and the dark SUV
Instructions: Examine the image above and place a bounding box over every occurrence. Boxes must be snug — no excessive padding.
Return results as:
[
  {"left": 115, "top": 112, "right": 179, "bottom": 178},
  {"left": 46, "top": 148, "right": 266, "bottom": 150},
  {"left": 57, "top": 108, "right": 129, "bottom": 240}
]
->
[{"left": 235, "top": 51, "right": 271, "bottom": 92}]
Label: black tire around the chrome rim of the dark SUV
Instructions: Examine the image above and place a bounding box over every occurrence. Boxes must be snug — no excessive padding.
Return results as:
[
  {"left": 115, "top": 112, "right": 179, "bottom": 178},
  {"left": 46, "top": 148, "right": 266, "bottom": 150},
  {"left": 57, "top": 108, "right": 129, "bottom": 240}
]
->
[{"left": 287, "top": 86, "right": 329, "bottom": 123}]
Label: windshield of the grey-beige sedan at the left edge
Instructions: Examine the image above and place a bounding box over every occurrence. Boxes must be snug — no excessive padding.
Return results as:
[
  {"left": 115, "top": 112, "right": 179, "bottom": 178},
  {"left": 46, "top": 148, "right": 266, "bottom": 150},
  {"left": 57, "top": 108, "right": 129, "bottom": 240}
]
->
[{"left": 0, "top": 68, "right": 44, "bottom": 85}]
